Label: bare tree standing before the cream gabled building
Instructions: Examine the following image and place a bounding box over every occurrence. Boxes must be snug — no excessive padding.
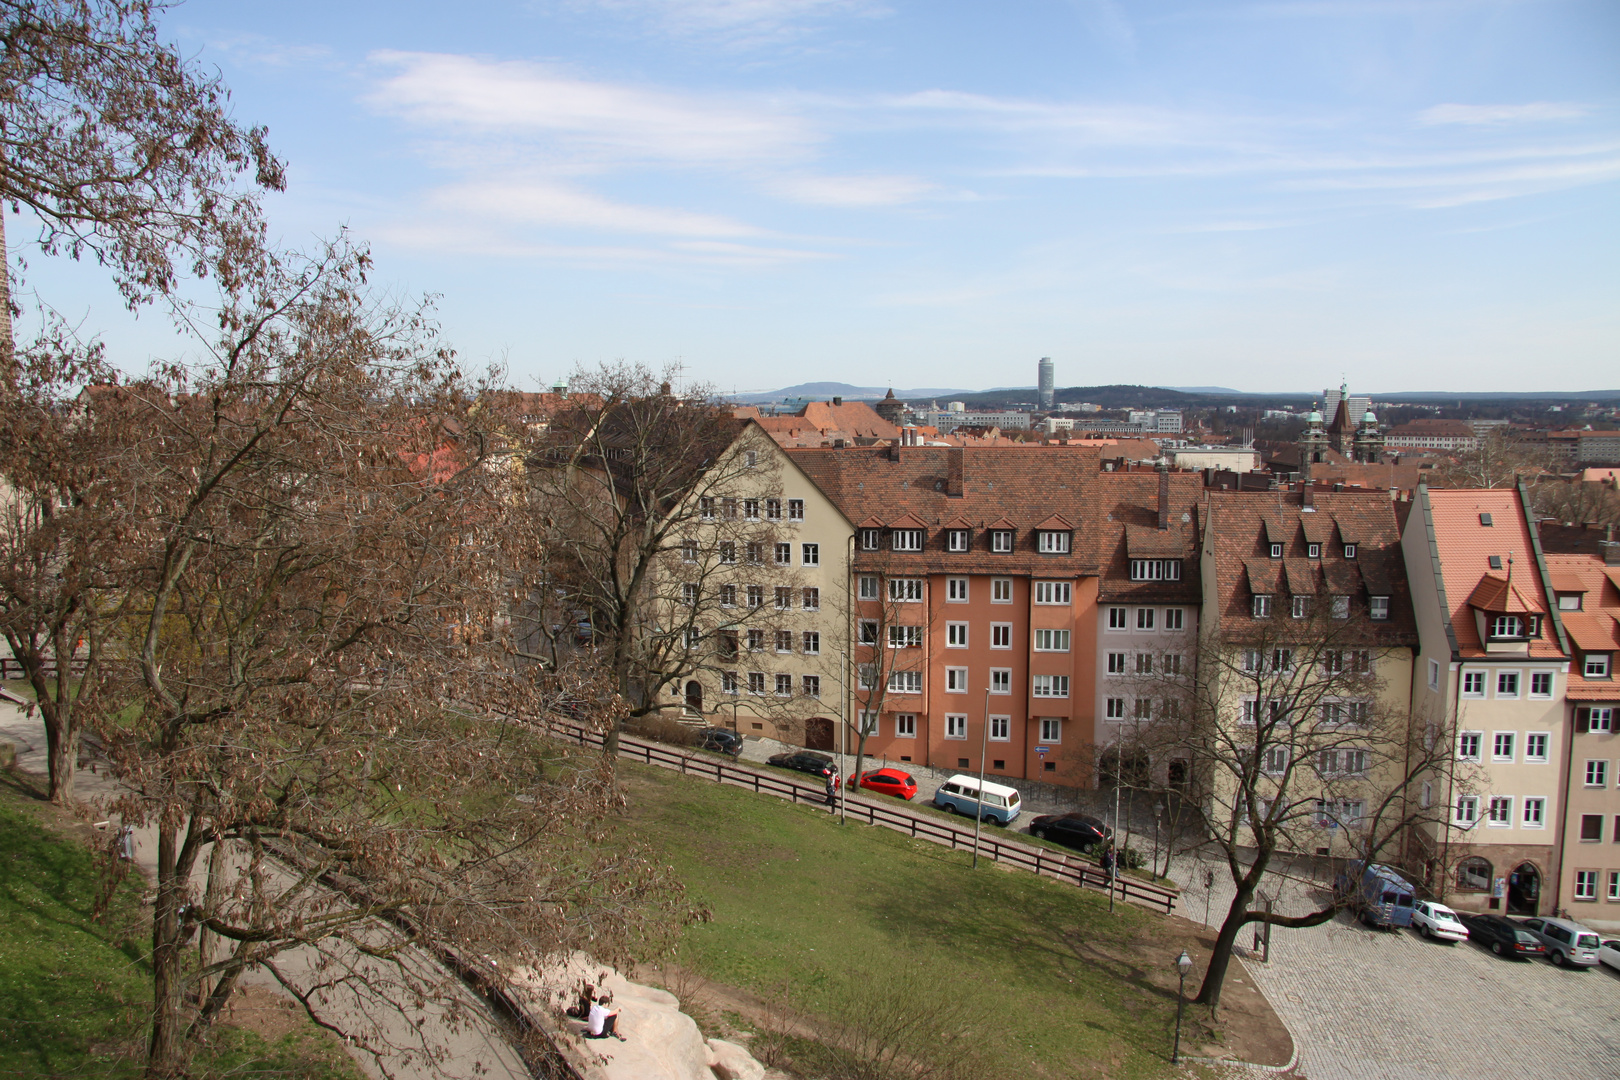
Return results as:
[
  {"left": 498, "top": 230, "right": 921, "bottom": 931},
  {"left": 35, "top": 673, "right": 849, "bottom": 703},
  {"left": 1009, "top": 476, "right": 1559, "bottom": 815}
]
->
[{"left": 510, "top": 364, "right": 810, "bottom": 753}]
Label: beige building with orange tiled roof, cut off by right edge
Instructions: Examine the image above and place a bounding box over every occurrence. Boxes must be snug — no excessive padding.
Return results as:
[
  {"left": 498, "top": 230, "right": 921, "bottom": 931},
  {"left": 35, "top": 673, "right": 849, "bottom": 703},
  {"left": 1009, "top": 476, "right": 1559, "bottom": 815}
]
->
[{"left": 1545, "top": 544, "right": 1620, "bottom": 931}]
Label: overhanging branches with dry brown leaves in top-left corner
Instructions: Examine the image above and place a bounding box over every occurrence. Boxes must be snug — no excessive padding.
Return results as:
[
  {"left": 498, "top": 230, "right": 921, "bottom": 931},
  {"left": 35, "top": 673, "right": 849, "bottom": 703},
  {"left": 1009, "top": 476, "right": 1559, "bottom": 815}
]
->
[{"left": 0, "top": 0, "right": 285, "bottom": 354}]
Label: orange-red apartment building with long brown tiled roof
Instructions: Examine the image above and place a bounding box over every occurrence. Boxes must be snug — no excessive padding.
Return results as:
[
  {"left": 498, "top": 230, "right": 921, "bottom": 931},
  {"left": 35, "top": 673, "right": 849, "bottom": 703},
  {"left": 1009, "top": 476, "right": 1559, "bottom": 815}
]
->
[{"left": 787, "top": 445, "right": 1114, "bottom": 785}]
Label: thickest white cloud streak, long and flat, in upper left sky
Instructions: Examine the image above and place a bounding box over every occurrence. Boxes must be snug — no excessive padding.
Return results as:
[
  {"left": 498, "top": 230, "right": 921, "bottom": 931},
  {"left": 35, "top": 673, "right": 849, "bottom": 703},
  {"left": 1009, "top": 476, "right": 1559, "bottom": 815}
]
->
[{"left": 368, "top": 52, "right": 816, "bottom": 164}]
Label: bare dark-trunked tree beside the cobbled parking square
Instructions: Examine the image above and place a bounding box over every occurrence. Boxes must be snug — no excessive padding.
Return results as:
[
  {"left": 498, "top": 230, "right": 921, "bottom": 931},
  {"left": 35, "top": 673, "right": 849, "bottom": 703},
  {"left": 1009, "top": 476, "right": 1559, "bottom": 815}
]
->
[{"left": 1119, "top": 593, "right": 1452, "bottom": 1007}]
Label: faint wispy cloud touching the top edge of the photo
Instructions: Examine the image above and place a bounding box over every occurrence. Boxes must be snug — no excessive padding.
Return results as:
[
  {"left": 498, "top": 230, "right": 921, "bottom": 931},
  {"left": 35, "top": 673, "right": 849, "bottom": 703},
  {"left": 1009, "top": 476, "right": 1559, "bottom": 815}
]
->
[{"left": 561, "top": 0, "right": 889, "bottom": 47}]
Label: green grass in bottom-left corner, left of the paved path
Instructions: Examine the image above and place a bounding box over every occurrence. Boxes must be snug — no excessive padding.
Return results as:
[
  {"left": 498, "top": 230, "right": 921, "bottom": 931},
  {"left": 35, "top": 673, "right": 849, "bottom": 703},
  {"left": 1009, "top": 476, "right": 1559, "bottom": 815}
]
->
[{"left": 0, "top": 774, "right": 360, "bottom": 1080}]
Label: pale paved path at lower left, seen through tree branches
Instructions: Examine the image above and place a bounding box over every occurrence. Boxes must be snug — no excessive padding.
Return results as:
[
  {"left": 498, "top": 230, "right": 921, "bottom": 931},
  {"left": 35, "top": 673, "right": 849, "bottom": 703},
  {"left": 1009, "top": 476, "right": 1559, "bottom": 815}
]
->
[{"left": 0, "top": 703, "right": 530, "bottom": 1080}]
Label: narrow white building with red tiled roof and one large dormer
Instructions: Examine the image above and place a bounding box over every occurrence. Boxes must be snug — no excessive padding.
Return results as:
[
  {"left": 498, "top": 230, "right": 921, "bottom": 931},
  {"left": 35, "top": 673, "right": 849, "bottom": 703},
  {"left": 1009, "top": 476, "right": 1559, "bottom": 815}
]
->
[{"left": 1401, "top": 486, "right": 1571, "bottom": 915}]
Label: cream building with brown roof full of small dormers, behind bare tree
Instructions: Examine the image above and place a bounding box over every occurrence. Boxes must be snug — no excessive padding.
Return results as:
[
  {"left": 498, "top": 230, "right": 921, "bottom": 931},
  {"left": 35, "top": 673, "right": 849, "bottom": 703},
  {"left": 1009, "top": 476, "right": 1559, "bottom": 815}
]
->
[{"left": 1199, "top": 489, "right": 1418, "bottom": 858}]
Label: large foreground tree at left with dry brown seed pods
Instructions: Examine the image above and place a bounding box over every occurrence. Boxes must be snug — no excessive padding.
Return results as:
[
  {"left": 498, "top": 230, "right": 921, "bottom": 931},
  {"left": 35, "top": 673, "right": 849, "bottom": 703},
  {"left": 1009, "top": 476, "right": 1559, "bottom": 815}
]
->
[{"left": 97, "top": 248, "right": 682, "bottom": 1077}]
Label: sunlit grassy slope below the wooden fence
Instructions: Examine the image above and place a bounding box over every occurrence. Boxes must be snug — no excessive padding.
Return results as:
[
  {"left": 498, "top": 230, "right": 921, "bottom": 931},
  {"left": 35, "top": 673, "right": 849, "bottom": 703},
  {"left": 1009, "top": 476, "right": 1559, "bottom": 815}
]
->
[{"left": 622, "top": 764, "right": 1175, "bottom": 1077}]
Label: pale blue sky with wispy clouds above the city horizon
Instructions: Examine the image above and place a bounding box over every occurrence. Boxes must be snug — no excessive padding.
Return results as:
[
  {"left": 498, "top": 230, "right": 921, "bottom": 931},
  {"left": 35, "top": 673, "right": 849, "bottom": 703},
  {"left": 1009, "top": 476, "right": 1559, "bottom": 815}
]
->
[{"left": 13, "top": 0, "right": 1620, "bottom": 390}]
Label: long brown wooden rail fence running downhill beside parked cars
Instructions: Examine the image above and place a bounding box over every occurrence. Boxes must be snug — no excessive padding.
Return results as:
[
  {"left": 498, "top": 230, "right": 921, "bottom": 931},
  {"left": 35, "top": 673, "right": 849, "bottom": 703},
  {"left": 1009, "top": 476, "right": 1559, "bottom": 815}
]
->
[{"left": 549, "top": 721, "right": 1179, "bottom": 915}]
